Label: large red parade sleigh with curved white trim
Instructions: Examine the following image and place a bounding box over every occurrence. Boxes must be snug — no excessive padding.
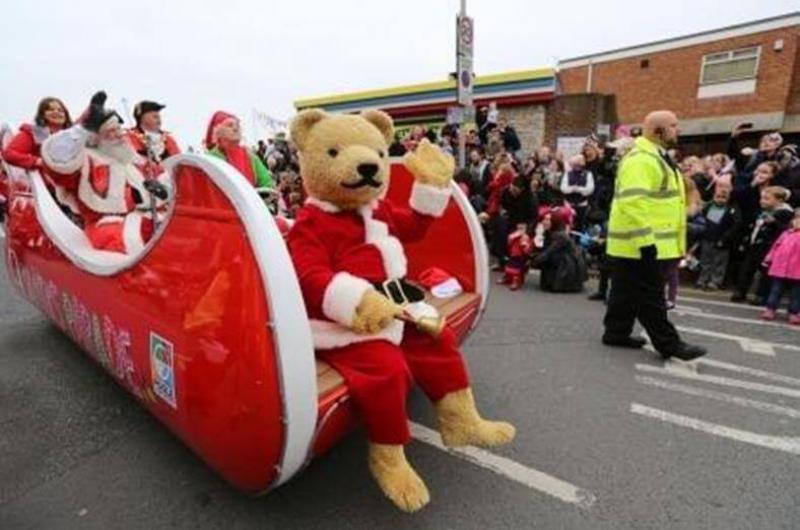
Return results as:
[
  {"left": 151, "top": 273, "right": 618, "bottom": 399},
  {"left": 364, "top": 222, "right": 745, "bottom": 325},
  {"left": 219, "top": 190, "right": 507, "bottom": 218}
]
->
[{"left": 1, "top": 154, "right": 488, "bottom": 494}]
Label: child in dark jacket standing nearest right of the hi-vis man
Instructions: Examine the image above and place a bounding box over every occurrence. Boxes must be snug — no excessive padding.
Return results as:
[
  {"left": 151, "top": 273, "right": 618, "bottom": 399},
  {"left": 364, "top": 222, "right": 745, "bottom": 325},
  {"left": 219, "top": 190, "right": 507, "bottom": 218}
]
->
[{"left": 695, "top": 186, "right": 739, "bottom": 291}]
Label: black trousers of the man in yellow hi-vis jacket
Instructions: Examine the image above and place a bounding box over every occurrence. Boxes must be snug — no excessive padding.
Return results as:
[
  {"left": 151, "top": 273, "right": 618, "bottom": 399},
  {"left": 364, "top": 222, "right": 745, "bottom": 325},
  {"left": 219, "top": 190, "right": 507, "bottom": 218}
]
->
[{"left": 603, "top": 258, "right": 681, "bottom": 354}]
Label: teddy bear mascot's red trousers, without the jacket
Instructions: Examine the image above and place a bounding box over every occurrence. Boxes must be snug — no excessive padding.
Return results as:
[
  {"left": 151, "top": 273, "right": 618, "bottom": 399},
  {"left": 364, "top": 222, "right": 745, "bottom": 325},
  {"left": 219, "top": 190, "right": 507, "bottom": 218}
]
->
[{"left": 317, "top": 325, "right": 469, "bottom": 445}]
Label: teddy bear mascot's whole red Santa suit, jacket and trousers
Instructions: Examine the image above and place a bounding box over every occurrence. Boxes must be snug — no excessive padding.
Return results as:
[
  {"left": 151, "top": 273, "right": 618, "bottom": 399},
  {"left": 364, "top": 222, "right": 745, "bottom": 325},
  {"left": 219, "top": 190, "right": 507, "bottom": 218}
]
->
[{"left": 288, "top": 180, "right": 469, "bottom": 444}]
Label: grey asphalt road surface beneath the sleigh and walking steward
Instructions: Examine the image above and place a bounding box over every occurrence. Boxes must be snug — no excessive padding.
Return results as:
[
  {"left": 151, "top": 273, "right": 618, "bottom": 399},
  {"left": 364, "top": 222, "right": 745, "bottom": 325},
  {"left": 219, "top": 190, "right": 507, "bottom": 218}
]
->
[{"left": 0, "top": 245, "right": 800, "bottom": 530}]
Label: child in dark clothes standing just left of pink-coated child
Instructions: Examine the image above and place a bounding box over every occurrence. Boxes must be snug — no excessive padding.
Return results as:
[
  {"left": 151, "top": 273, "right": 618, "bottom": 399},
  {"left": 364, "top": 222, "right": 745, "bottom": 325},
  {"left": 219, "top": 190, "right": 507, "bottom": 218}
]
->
[{"left": 731, "top": 186, "right": 793, "bottom": 304}]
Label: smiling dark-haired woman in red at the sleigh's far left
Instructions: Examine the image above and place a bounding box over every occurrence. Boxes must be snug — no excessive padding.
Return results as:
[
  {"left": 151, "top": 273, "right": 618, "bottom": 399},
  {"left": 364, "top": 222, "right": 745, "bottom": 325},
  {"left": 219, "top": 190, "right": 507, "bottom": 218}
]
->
[{"left": 3, "top": 97, "right": 72, "bottom": 170}]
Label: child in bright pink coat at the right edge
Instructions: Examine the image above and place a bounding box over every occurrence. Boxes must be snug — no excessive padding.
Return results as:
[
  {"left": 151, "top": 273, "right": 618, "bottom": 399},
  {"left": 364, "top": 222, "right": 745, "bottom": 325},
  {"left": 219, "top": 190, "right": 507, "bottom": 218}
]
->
[{"left": 761, "top": 208, "right": 800, "bottom": 326}]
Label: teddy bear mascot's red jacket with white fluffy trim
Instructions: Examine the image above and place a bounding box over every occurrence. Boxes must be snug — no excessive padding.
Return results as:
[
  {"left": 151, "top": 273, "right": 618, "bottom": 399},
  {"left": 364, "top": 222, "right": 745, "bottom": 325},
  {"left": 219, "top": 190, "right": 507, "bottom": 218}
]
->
[{"left": 288, "top": 184, "right": 450, "bottom": 349}]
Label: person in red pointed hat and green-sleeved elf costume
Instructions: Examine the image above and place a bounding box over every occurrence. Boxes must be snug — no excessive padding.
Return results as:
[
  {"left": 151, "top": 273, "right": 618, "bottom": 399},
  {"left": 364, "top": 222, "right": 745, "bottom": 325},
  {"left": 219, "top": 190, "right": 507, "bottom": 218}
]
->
[{"left": 206, "top": 110, "right": 274, "bottom": 188}]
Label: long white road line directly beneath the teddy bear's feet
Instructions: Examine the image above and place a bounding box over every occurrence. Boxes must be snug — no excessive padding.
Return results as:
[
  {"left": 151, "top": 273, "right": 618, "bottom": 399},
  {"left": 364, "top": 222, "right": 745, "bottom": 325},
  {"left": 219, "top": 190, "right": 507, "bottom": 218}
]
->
[{"left": 411, "top": 422, "right": 596, "bottom": 508}]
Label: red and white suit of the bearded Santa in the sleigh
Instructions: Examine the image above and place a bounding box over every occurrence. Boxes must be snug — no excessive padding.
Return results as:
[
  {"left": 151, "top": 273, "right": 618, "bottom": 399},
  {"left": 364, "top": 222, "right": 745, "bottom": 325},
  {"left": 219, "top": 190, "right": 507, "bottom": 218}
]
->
[{"left": 42, "top": 130, "right": 168, "bottom": 254}]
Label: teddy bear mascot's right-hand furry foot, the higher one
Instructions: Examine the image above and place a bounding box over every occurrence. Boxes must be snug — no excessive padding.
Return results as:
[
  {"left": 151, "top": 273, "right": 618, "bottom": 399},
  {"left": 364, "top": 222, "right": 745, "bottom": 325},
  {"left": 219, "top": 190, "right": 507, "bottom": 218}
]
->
[{"left": 435, "top": 388, "right": 516, "bottom": 447}]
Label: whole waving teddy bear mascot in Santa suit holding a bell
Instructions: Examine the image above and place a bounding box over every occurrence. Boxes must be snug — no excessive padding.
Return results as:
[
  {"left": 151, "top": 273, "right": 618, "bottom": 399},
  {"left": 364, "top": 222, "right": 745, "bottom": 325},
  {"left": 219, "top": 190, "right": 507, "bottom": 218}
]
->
[{"left": 288, "top": 109, "right": 515, "bottom": 512}]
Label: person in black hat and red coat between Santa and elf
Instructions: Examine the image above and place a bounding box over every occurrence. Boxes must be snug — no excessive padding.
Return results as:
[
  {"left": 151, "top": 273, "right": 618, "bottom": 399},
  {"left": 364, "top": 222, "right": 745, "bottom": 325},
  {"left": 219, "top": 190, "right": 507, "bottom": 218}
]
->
[{"left": 126, "top": 101, "right": 181, "bottom": 170}]
